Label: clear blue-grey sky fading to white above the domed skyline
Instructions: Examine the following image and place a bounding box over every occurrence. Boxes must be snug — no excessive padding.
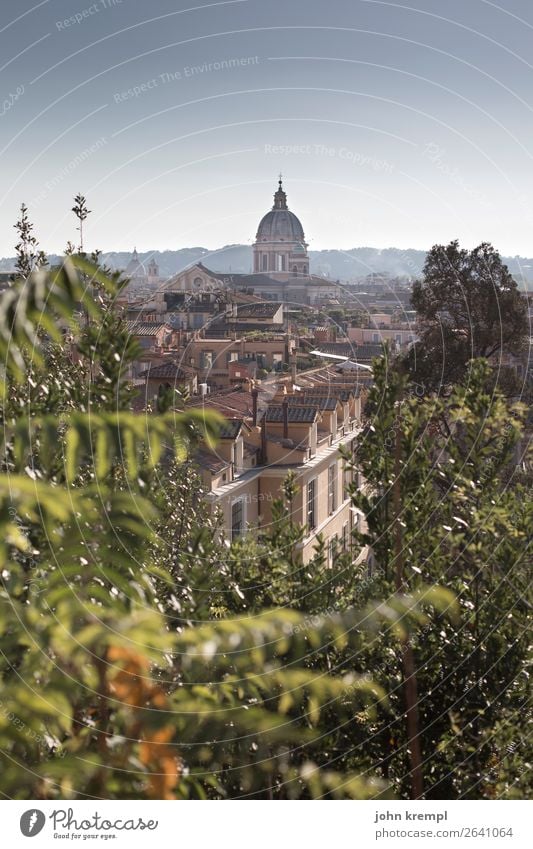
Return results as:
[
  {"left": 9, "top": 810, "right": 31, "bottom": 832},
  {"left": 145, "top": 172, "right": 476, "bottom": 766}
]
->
[{"left": 0, "top": 0, "right": 533, "bottom": 256}]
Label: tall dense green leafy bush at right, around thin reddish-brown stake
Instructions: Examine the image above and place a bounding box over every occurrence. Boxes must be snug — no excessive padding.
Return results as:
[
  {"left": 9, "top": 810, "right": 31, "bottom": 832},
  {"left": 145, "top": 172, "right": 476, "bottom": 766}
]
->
[{"left": 352, "top": 360, "right": 533, "bottom": 799}]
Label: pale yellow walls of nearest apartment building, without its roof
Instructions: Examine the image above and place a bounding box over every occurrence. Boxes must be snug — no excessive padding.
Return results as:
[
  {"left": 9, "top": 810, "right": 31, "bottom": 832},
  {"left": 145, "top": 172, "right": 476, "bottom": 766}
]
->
[{"left": 201, "top": 388, "right": 366, "bottom": 563}]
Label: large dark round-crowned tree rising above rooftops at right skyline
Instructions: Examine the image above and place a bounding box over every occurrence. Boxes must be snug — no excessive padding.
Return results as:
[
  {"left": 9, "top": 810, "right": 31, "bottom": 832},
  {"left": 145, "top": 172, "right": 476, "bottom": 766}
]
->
[{"left": 406, "top": 241, "right": 528, "bottom": 392}]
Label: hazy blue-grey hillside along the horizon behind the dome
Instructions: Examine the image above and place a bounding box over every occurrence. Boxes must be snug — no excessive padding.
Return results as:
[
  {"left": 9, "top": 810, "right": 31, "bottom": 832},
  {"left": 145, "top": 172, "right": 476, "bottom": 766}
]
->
[{"left": 0, "top": 245, "right": 533, "bottom": 284}]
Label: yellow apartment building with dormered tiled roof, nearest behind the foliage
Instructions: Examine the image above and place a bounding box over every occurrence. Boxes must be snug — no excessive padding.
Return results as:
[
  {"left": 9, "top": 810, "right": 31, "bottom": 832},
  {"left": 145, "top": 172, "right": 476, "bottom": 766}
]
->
[{"left": 189, "top": 370, "right": 362, "bottom": 563}]
